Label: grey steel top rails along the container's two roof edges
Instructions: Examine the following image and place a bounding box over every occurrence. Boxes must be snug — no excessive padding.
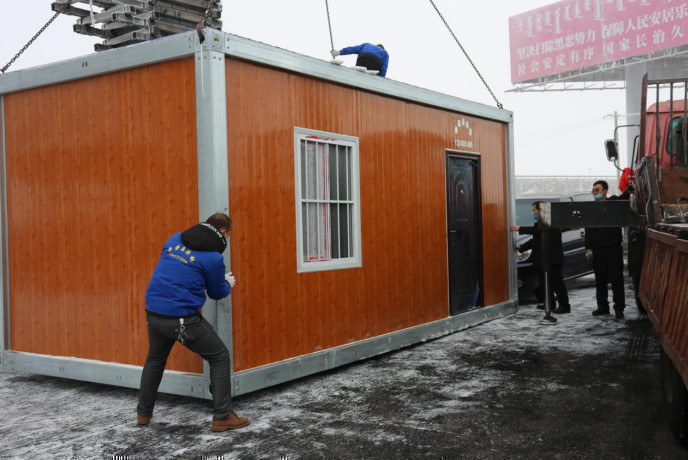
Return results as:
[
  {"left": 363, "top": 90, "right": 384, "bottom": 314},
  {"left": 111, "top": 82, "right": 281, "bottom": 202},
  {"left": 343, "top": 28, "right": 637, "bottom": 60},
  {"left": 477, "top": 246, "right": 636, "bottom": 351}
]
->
[{"left": 0, "top": 29, "right": 513, "bottom": 123}]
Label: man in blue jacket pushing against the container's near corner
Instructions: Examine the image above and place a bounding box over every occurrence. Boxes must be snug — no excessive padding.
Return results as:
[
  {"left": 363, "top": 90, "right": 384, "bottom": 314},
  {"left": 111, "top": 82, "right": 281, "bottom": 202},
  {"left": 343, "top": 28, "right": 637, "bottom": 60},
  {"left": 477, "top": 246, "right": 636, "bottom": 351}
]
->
[{"left": 136, "top": 213, "right": 249, "bottom": 431}]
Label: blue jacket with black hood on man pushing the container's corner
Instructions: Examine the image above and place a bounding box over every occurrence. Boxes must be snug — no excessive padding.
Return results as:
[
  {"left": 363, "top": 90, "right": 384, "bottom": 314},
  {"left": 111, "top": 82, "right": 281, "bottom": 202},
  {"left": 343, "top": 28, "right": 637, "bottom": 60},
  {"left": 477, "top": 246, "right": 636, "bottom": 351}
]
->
[{"left": 146, "top": 223, "right": 231, "bottom": 316}]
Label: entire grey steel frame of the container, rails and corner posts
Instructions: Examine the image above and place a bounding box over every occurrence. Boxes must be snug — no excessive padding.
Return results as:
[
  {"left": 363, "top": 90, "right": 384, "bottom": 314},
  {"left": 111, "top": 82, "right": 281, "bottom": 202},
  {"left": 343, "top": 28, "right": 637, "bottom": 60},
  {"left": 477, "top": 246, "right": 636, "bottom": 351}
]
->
[{"left": 0, "top": 29, "right": 517, "bottom": 399}]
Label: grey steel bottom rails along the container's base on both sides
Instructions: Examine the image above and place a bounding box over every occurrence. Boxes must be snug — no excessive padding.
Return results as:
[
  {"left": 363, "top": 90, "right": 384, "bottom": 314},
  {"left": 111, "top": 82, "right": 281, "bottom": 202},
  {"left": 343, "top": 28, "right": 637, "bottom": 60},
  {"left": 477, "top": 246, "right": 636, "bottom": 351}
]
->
[{"left": 2, "top": 301, "right": 516, "bottom": 399}]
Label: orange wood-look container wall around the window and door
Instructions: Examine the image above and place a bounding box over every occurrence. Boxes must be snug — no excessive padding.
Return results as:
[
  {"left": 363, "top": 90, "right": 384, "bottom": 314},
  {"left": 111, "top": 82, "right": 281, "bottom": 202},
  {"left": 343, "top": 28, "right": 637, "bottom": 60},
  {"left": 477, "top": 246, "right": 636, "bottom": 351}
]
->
[{"left": 226, "top": 59, "right": 509, "bottom": 371}]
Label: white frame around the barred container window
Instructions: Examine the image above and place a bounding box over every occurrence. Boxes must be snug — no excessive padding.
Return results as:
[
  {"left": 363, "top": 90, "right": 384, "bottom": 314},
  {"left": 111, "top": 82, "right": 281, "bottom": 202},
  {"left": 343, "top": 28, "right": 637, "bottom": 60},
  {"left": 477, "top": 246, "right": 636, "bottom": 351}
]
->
[{"left": 294, "top": 127, "right": 362, "bottom": 273}]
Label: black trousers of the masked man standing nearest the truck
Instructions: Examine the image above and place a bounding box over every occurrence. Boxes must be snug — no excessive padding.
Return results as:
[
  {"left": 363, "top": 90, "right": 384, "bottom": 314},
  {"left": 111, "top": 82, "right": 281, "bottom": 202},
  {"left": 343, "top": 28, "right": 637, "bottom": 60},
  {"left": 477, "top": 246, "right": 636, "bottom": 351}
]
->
[{"left": 592, "top": 244, "right": 626, "bottom": 311}]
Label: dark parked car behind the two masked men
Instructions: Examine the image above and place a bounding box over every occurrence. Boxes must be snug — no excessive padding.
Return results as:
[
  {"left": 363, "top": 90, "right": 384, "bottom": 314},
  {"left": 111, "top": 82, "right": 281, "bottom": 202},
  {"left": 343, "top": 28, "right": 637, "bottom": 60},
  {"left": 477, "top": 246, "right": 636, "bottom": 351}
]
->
[{"left": 516, "top": 193, "right": 592, "bottom": 303}]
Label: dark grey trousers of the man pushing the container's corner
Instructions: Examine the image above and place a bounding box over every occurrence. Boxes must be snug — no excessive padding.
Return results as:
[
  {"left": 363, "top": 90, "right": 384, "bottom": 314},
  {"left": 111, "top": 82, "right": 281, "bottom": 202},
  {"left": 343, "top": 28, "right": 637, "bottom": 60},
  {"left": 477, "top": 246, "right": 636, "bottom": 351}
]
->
[{"left": 136, "top": 314, "right": 232, "bottom": 420}]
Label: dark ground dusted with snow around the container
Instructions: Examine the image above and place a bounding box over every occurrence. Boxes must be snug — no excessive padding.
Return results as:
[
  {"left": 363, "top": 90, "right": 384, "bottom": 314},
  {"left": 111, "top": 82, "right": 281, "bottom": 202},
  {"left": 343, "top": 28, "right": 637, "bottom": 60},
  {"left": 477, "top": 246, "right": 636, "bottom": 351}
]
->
[{"left": 0, "top": 278, "right": 688, "bottom": 459}]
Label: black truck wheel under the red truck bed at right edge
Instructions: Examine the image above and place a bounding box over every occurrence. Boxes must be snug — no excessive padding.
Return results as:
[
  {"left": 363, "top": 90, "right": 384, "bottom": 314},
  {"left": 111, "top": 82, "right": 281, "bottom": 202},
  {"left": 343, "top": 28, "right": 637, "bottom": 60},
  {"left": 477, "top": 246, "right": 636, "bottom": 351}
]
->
[{"left": 659, "top": 350, "right": 688, "bottom": 443}]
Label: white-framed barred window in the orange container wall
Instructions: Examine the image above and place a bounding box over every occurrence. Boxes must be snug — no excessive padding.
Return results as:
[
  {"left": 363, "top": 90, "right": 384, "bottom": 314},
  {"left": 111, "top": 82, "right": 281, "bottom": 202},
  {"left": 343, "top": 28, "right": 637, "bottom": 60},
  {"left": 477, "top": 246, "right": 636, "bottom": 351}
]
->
[{"left": 294, "top": 128, "right": 361, "bottom": 272}]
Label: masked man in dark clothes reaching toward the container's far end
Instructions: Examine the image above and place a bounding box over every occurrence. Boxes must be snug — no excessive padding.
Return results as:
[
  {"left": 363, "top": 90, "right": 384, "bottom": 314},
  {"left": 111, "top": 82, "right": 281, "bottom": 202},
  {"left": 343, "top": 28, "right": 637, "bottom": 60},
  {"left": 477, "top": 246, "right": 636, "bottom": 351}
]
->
[{"left": 510, "top": 201, "right": 571, "bottom": 314}]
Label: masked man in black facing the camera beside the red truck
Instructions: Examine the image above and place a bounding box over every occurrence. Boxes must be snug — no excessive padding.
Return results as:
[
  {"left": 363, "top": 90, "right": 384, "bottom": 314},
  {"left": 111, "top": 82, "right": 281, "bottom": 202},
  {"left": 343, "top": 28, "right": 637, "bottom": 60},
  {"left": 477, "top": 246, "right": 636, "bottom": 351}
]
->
[{"left": 585, "top": 180, "right": 628, "bottom": 319}]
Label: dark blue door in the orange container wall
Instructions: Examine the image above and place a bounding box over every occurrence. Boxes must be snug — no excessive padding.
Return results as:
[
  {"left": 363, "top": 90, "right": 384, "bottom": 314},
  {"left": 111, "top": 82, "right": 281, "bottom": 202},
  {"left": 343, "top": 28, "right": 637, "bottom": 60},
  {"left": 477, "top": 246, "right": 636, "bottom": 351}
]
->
[{"left": 447, "top": 155, "right": 482, "bottom": 315}]
